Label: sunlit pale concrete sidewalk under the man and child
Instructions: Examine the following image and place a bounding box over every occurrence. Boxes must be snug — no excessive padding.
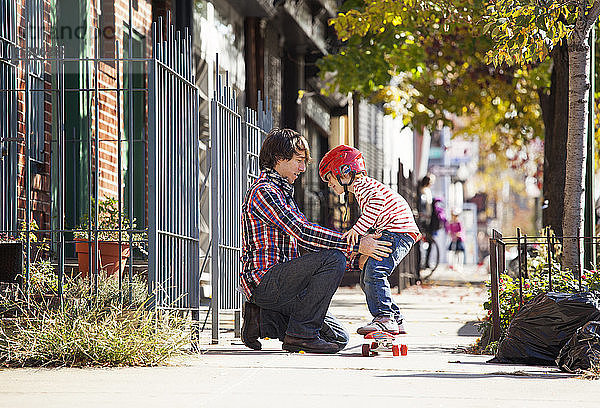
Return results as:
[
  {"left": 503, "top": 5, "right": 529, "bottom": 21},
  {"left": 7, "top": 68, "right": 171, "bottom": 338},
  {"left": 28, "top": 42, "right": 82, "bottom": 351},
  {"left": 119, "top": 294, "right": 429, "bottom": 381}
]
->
[{"left": 0, "top": 269, "right": 600, "bottom": 408}]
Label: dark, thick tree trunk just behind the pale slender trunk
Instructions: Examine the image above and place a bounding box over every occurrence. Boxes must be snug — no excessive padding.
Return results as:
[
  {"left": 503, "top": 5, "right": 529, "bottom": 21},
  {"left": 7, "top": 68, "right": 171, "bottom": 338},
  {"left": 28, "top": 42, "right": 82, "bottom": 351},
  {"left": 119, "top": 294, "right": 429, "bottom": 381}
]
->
[{"left": 539, "top": 41, "right": 569, "bottom": 236}]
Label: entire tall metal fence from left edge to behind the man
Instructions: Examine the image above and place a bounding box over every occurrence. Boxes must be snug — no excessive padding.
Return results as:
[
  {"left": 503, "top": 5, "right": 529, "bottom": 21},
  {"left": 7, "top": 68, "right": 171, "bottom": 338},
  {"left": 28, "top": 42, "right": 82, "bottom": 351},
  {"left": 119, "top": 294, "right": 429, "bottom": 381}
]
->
[{"left": 0, "top": 2, "right": 273, "bottom": 341}]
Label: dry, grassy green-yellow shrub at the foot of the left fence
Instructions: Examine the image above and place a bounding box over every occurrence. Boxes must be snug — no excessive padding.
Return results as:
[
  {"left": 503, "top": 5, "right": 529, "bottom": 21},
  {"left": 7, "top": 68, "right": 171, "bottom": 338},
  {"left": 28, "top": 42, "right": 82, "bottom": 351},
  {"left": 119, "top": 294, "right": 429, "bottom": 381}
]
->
[{"left": 0, "top": 271, "right": 189, "bottom": 366}]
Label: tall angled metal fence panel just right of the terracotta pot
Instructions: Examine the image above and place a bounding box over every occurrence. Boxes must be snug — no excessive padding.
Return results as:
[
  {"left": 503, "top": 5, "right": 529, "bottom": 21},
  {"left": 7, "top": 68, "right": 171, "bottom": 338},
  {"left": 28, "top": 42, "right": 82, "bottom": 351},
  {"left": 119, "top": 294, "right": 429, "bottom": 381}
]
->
[{"left": 148, "top": 20, "right": 201, "bottom": 317}]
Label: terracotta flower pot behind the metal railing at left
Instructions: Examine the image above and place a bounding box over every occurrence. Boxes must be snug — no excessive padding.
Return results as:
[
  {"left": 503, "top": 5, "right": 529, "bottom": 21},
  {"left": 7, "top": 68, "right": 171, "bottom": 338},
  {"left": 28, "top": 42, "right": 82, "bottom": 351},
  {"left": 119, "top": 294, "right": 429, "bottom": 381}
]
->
[{"left": 75, "top": 239, "right": 130, "bottom": 278}]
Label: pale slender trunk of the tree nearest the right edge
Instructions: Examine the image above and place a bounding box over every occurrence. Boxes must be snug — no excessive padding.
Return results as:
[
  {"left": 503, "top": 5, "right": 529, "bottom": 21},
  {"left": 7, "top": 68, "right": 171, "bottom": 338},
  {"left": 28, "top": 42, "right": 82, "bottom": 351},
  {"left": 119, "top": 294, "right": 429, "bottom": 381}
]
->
[{"left": 563, "top": 28, "right": 590, "bottom": 272}]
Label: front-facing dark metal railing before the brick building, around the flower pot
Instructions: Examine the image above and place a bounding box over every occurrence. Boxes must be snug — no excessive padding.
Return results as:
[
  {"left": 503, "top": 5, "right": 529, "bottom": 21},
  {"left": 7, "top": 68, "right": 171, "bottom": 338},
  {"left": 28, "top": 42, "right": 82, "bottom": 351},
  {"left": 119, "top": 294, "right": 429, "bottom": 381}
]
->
[{"left": 0, "top": 0, "right": 159, "bottom": 301}]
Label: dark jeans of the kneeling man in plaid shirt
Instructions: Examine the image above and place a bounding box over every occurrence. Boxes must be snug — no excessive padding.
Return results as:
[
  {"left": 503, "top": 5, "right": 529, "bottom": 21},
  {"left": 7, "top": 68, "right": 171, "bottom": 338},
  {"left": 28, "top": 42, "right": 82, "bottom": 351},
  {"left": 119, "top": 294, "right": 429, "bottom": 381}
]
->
[{"left": 251, "top": 249, "right": 347, "bottom": 345}]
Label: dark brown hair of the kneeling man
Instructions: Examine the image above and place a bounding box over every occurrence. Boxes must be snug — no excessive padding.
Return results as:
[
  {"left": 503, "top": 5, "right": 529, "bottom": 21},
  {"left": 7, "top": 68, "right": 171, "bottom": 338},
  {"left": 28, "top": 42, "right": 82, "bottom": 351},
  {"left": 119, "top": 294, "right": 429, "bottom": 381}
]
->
[{"left": 258, "top": 128, "right": 310, "bottom": 170}]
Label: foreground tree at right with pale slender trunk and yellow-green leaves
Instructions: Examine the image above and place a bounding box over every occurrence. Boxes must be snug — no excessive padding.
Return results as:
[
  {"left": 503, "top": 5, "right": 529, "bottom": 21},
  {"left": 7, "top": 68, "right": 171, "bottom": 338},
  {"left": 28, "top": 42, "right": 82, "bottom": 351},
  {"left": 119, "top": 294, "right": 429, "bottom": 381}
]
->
[{"left": 486, "top": 0, "right": 600, "bottom": 270}]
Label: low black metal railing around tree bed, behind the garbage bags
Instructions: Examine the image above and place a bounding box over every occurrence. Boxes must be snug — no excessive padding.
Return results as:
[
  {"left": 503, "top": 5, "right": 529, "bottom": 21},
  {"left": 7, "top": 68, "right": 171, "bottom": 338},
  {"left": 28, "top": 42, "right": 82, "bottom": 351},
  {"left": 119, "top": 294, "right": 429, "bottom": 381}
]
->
[{"left": 489, "top": 228, "right": 600, "bottom": 341}]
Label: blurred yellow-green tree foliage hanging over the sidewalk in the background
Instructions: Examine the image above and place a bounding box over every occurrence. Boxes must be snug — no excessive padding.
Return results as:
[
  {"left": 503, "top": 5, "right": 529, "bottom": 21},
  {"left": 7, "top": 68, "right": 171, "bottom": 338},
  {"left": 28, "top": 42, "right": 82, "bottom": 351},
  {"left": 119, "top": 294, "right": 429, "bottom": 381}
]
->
[{"left": 320, "top": 0, "right": 548, "bottom": 228}]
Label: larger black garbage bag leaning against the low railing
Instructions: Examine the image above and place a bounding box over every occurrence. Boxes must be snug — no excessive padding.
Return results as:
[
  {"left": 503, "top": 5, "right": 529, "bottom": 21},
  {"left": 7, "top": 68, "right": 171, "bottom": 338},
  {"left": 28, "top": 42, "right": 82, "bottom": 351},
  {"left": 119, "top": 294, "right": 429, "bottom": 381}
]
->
[{"left": 490, "top": 292, "right": 600, "bottom": 366}]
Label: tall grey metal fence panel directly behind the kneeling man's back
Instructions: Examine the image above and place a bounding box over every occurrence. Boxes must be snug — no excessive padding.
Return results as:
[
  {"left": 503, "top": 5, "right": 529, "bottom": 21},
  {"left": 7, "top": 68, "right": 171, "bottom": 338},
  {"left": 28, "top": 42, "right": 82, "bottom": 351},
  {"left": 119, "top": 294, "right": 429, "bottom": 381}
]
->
[{"left": 210, "top": 63, "right": 273, "bottom": 343}]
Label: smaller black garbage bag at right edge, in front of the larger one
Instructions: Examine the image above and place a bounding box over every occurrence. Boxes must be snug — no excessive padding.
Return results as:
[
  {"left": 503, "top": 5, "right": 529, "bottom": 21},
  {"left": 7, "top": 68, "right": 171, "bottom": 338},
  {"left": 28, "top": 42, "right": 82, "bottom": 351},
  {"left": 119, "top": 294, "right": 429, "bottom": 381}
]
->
[{"left": 556, "top": 321, "right": 600, "bottom": 373}]
